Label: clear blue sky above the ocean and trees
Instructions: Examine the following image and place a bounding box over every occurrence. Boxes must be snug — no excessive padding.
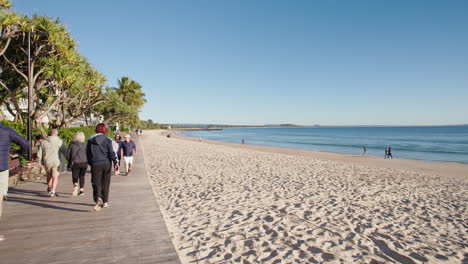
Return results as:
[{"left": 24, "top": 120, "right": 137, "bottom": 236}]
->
[{"left": 13, "top": 0, "right": 468, "bottom": 125}]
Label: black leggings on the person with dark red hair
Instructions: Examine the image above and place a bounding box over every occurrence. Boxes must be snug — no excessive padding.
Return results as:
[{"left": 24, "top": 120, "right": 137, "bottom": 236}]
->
[{"left": 91, "top": 163, "right": 112, "bottom": 203}]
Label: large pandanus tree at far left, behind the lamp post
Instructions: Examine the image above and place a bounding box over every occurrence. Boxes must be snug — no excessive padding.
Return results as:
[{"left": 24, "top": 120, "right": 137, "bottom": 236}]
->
[{"left": 0, "top": 13, "right": 76, "bottom": 126}]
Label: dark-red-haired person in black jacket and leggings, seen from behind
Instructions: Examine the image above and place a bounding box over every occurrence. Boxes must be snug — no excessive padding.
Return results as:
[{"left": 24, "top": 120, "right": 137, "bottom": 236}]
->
[{"left": 86, "top": 123, "right": 119, "bottom": 211}]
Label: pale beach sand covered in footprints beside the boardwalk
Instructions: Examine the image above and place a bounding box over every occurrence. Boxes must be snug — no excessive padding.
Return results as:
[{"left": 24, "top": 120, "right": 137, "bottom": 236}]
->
[{"left": 140, "top": 131, "right": 468, "bottom": 263}]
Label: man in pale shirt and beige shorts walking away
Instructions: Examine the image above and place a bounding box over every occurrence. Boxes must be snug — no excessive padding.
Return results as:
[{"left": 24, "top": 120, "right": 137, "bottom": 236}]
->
[{"left": 37, "top": 129, "right": 67, "bottom": 197}]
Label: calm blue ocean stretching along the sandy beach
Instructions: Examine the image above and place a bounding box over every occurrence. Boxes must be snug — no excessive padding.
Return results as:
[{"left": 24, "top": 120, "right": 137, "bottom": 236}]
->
[{"left": 180, "top": 126, "right": 468, "bottom": 163}]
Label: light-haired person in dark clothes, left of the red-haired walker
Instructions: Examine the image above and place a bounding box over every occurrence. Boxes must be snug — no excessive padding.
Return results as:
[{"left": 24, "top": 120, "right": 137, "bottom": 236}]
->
[{"left": 67, "top": 131, "right": 88, "bottom": 196}]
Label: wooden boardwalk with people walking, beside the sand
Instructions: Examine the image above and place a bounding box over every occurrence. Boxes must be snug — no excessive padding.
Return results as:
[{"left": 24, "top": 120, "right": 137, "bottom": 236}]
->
[{"left": 0, "top": 137, "right": 180, "bottom": 264}]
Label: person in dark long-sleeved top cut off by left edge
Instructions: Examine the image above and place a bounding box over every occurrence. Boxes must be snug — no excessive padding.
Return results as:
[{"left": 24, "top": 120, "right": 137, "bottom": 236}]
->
[{"left": 0, "top": 122, "right": 30, "bottom": 241}]
